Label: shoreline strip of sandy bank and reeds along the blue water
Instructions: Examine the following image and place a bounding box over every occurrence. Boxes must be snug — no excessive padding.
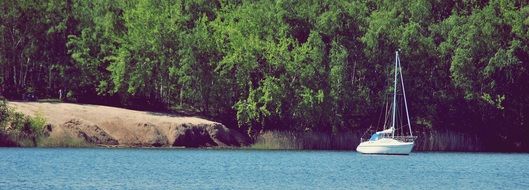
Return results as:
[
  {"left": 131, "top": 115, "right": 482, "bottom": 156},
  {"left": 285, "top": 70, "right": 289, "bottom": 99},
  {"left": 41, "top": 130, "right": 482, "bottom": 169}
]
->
[{"left": 0, "top": 101, "right": 528, "bottom": 153}]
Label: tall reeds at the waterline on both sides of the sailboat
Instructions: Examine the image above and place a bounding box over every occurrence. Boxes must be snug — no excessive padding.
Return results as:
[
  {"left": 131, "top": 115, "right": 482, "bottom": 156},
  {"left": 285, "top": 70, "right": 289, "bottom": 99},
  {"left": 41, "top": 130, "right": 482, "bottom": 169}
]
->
[{"left": 251, "top": 131, "right": 486, "bottom": 151}]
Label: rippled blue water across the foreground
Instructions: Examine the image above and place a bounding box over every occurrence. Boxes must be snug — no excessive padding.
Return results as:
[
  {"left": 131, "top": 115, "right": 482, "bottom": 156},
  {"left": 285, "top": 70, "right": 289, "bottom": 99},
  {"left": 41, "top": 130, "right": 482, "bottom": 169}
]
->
[{"left": 0, "top": 148, "right": 529, "bottom": 189}]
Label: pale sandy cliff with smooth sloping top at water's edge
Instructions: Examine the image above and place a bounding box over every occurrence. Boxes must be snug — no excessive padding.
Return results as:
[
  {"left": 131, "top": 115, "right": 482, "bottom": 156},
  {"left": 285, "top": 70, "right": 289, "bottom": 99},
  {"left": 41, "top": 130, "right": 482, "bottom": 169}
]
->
[{"left": 8, "top": 102, "right": 249, "bottom": 147}]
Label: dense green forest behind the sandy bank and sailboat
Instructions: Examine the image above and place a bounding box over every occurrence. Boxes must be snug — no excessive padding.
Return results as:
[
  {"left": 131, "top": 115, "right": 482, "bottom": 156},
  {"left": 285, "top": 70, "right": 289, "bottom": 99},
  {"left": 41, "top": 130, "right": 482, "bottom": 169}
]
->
[{"left": 0, "top": 0, "right": 529, "bottom": 150}]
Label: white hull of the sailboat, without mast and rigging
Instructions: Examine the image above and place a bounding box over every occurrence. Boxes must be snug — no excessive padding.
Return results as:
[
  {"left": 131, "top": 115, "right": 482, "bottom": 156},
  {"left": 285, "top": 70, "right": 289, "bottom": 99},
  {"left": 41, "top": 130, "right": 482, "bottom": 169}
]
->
[{"left": 356, "top": 138, "right": 414, "bottom": 155}]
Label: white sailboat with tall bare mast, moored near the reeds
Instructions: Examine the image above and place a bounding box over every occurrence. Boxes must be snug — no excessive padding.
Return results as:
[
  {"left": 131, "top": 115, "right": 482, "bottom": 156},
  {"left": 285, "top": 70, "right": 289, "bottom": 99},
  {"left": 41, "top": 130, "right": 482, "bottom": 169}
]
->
[{"left": 356, "top": 51, "right": 417, "bottom": 155}]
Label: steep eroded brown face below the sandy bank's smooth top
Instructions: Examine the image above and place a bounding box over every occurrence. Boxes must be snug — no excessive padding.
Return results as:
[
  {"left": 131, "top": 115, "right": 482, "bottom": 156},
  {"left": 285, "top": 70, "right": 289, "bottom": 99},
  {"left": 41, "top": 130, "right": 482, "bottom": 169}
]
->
[{"left": 56, "top": 119, "right": 249, "bottom": 147}]
